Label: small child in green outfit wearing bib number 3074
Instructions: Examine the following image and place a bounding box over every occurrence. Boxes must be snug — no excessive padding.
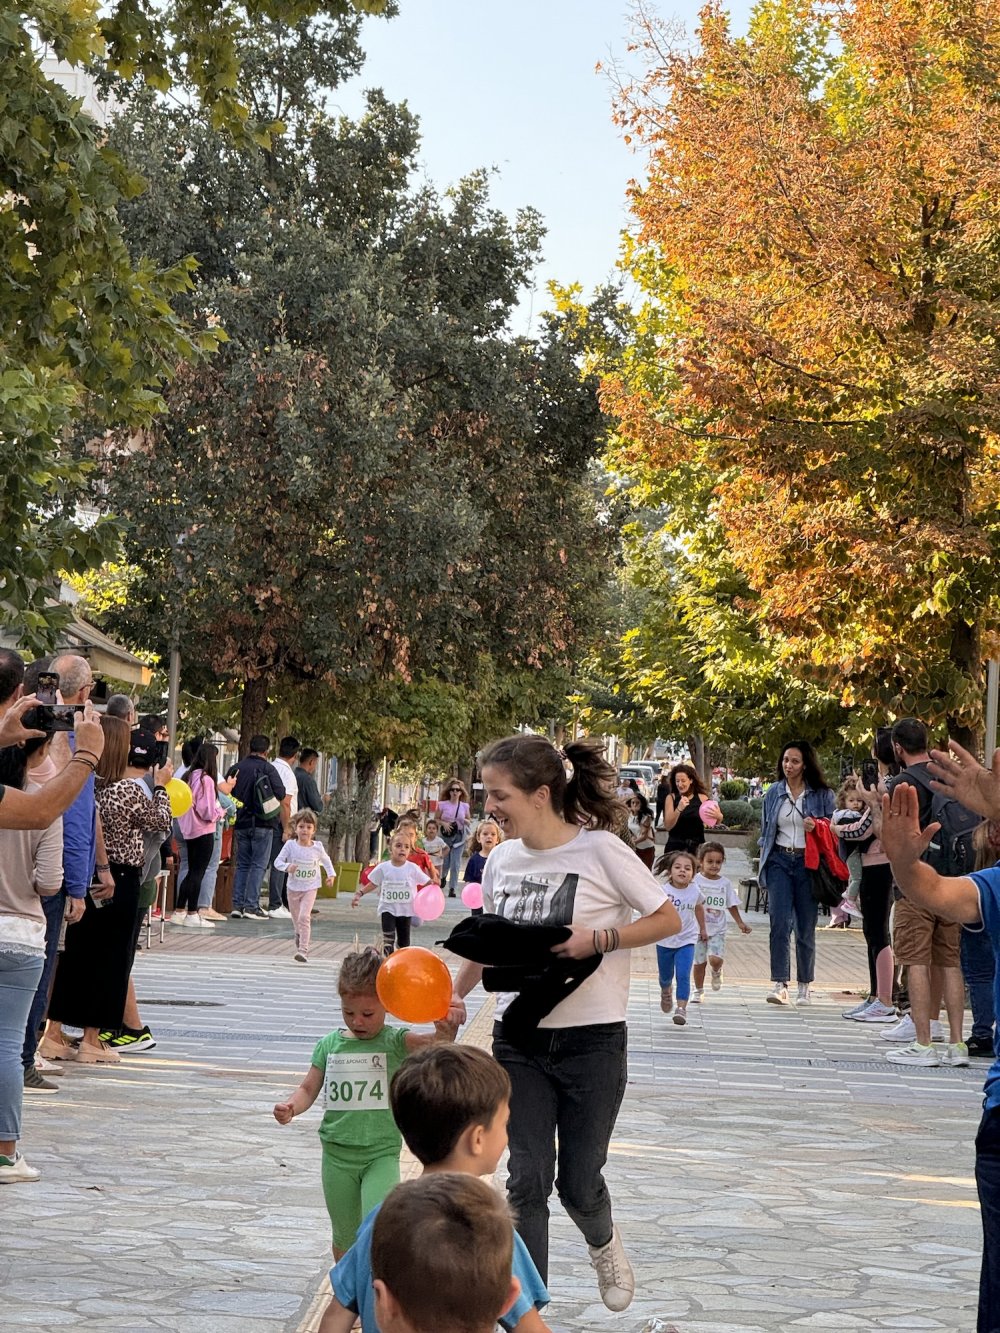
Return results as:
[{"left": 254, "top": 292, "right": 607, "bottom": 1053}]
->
[{"left": 275, "top": 949, "right": 457, "bottom": 1258}]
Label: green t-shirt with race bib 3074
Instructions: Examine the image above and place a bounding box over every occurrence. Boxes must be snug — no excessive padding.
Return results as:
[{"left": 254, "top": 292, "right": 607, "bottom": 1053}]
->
[{"left": 312, "top": 1026, "right": 408, "bottom": 1153}]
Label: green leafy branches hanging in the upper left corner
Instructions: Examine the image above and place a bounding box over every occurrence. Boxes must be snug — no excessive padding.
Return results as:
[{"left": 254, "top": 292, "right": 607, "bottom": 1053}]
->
[{"left": 0, "top": 0, "right": 385, "bottom": 649}]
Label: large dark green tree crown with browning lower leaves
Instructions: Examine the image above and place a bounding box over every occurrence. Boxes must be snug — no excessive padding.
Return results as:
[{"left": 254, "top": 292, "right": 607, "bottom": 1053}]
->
[{"left": 92, "top": 25, "right": 608, "bottom": 765}]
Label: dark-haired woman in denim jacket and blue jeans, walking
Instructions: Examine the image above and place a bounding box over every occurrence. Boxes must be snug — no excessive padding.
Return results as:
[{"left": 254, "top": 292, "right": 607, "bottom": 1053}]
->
[{"left": 757, "top": 741, "right": 833, "bottom": 1005}]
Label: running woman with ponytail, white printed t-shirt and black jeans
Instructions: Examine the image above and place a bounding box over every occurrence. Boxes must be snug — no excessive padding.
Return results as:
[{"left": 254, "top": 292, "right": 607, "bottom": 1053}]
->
[{"left": 455, "top": 736, "right": 680, "bottom": 1310}]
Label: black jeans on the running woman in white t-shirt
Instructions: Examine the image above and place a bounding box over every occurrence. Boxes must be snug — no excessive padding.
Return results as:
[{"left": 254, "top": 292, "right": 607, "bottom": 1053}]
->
[{"left": 493, "top": 1022, "right": 628, "bottom": 1282}]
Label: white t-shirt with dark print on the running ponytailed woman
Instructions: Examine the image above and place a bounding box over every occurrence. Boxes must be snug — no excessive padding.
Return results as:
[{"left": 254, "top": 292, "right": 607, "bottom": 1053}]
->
[{"left": 483, "top": 829, "right": 664, "bottom": 1029}]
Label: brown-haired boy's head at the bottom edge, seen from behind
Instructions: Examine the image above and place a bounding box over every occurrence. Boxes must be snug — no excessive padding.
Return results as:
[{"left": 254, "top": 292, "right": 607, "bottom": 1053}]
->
[{"left": 372, "top": 1172, "right": 519, "bottom": 1333}]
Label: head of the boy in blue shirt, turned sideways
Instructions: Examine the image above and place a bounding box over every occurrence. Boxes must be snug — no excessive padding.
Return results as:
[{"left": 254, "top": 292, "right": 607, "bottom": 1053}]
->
[{"left": 389, "top": 1045, "right": 511, "bottom": 1176}]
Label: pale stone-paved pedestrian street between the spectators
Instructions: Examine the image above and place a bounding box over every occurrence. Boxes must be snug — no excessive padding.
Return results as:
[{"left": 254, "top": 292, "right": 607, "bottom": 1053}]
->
[{"left": 0, "top": 902, "right": 985, "bottom": 1333}]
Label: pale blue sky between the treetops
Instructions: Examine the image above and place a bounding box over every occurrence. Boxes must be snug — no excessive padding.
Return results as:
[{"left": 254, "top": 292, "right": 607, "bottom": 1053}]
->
[{"left": 333, "top": 0, "right": 745, "bottom": 333}]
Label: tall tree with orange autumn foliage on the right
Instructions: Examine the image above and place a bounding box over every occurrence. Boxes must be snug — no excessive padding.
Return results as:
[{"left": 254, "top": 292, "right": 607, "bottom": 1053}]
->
[{"left": 605, "top": 0, "right": 1000, "bottom": 740}]
